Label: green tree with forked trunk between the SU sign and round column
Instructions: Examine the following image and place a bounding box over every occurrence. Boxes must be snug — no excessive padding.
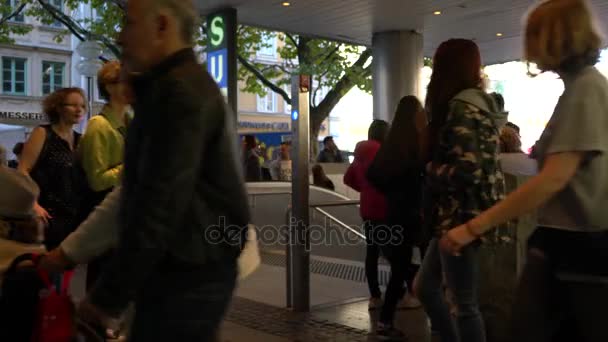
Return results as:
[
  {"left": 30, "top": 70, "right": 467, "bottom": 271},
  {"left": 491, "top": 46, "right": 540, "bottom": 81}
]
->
[{"left": 230, "top": 26, "right": 372, "bottom": 152}]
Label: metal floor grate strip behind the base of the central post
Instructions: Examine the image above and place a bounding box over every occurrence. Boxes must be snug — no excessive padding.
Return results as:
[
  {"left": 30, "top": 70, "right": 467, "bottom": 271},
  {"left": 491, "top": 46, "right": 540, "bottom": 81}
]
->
[{"left": 262, "top": 253, "right": 391, "bottom": 286}]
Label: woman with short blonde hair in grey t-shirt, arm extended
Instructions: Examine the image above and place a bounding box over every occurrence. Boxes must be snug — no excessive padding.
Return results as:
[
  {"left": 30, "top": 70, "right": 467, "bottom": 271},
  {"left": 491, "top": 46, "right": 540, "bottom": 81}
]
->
[{"left": 441, "top": 0, "right": 608, "bottom": 342}]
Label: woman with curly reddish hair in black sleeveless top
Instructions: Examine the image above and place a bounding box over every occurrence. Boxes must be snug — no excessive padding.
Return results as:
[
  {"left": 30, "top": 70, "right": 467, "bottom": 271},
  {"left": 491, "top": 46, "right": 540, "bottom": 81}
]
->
[{"left": 19, "top": 88, "right": 87, "bottom": 250}]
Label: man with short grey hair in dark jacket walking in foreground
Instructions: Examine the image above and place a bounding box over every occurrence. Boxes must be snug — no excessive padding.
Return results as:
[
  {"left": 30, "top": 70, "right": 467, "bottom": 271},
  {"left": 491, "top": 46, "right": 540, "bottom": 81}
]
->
[{"left": 80, "top": 0, "right": 249, "bottom": 341}]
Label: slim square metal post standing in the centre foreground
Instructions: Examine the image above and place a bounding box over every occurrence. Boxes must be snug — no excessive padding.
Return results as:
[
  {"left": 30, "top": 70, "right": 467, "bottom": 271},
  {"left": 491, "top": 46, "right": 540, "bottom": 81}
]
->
[{"left": 287, "top": 75, "right": 310, "bottom": 312}]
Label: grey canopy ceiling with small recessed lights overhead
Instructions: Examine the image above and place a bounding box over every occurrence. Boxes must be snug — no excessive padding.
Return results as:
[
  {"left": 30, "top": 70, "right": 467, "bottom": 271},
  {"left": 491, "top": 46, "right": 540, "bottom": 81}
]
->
[{"left": 197, "top": 0, "right": 608, "bottom": 64}]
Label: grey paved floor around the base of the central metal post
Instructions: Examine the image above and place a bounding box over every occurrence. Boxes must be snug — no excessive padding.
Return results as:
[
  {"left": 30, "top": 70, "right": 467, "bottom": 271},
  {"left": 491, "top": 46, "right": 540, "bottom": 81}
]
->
[{"left": 95, "top": 253, "right": 436, "bottom": 342}]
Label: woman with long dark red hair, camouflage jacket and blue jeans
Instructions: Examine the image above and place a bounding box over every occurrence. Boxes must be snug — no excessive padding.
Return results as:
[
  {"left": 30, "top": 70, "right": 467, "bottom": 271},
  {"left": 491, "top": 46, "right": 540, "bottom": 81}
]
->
[{"left": 417, "top": 39, "right": 506, "bottom": 342}]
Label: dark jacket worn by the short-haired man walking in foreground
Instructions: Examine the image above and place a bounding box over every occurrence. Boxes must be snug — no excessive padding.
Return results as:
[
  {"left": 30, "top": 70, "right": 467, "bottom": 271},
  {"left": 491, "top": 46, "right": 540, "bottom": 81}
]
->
[{"left": 91, "top": 49, "right": 249, "bottom": 313}]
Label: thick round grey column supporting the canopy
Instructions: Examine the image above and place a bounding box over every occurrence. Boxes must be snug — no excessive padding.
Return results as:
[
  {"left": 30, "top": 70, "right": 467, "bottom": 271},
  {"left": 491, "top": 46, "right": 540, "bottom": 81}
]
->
[{"left": 372, "top": 31, "right": 423, "bottom": 123}]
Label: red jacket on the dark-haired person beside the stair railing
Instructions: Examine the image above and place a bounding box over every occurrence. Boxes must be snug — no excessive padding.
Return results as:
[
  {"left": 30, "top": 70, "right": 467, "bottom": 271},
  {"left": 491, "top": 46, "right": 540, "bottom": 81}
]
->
[{"left": 344, "top": 140, "right": 387, "bottom": 221}]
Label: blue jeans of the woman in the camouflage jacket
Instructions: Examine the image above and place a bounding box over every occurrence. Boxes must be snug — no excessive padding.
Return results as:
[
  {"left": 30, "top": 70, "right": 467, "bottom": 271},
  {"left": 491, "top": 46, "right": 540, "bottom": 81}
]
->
[{"left": 418, "top": 239, "right": 486, "bottom": 342}]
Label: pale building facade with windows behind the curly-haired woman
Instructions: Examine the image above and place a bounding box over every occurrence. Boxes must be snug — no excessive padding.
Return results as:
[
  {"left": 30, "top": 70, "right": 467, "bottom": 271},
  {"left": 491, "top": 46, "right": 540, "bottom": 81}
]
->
[{"left": 0, "top": 0, "right": 102, "bottom": 159}]
